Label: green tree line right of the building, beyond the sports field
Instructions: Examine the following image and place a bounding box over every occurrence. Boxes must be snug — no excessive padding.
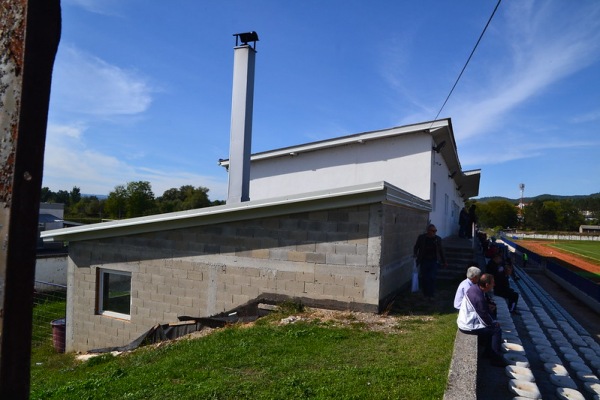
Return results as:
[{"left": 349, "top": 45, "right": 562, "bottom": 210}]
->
[{"left": 470, "top": 196, "right": 600, "bottom": 232}]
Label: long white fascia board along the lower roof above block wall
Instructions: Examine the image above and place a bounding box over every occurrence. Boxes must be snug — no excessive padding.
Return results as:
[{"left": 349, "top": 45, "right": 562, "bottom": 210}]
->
[{"left": 40, "top": 182, "right": 431, "bottom": 241}]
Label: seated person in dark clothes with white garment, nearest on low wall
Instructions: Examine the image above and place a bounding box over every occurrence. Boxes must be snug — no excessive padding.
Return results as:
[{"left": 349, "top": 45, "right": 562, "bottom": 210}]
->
[{"left": 456, "top": 274, "right": 507, "bottom": 367}]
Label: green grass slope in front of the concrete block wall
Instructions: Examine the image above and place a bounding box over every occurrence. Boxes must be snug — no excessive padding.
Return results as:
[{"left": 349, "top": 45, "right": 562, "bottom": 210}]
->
[{"left": 31, "top": 282, "right": 456, "bottom": 400}]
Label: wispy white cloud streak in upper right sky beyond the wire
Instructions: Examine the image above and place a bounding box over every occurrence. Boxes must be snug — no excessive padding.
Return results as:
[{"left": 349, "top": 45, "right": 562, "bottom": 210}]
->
[{"left": 449, "top": 2, "right": 600, "bottom": 139}]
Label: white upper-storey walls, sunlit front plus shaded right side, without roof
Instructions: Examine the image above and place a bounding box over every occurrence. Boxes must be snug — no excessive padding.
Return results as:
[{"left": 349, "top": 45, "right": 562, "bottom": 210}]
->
[{"left": 250, "top": 133, "right": 464, "bottom": 237}]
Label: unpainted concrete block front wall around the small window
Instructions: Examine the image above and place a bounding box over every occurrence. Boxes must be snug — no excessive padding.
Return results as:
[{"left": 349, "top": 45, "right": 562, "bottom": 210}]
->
[{"left": 67, "top": 203, "right": 394, "bottom": 351}]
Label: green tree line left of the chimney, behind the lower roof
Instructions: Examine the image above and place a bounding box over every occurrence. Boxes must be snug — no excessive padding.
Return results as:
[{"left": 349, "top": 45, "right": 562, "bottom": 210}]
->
[{"left": 41, "top": 181, "right": 225, "bottom": 223}]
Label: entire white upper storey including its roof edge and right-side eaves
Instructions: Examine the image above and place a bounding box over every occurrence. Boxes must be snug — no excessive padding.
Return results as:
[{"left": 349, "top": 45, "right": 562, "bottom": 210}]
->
[{"left": 221, "top": 119, "right": 480, "bottom": 237}]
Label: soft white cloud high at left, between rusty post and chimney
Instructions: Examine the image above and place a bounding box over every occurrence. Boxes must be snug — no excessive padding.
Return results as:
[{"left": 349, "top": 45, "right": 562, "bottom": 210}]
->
[{"left": 51, "top": 46, "right": 155, "bottom": 118}]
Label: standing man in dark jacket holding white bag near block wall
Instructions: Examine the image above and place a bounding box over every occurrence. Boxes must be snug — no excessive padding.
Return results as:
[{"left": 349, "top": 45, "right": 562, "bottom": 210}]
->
[{"left": 413, "top": 224, "right": 448, "bottom": 297}]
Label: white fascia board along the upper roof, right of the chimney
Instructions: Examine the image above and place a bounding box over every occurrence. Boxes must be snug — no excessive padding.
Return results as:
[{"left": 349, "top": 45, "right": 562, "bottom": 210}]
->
[{"left": 219, "top": 119, "right": 449, "bottom": 168}]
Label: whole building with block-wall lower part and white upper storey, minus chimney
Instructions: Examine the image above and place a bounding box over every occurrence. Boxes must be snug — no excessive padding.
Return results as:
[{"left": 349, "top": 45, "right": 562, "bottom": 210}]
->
[{"left": 42, "top": 120, "right": 479, "bottom": 351}]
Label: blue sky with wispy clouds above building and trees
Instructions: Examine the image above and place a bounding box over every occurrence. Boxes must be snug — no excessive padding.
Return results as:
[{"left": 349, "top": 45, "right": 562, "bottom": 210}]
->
[{"left": 43, "top": 0, "right": 600, "bottom": 200}]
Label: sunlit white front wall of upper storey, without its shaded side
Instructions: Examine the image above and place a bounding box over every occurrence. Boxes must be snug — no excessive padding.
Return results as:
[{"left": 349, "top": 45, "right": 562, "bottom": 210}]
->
[{"left": 250, "top": 134, "right": 431, "bottom": 200}]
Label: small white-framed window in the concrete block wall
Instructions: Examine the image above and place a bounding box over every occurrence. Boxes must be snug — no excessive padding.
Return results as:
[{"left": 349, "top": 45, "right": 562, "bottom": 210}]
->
[{"left": 98, "top": 269, "right": 131, "bottom": 319}]
